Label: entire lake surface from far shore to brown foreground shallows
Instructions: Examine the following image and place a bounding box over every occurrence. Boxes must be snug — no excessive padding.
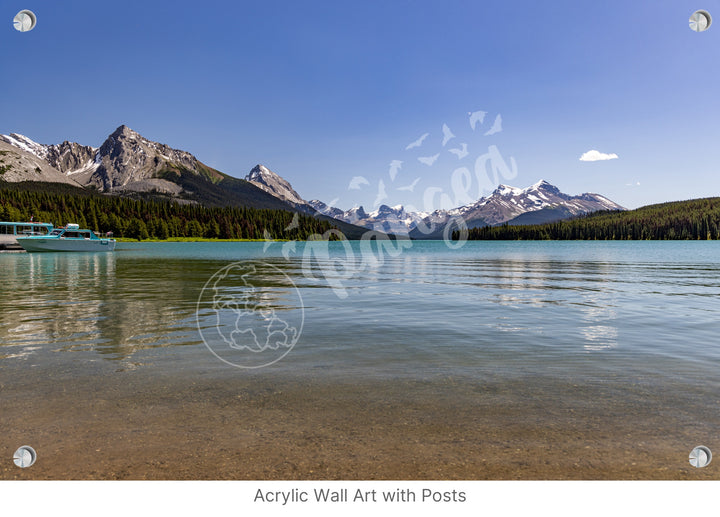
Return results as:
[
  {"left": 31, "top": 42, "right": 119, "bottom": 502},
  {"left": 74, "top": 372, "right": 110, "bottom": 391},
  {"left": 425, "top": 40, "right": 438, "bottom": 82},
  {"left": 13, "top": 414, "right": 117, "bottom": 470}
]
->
[{"left": 0, "top": 241, "right": 720, "bottom": 479}]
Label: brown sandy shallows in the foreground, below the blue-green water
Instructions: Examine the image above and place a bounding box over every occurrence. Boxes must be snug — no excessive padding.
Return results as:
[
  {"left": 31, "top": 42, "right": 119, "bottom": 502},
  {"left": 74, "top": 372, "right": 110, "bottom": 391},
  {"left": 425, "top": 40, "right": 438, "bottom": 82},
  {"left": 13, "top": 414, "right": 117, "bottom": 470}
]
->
[{"left": 0, "top": 370, "right": 720, "bottom": 480}]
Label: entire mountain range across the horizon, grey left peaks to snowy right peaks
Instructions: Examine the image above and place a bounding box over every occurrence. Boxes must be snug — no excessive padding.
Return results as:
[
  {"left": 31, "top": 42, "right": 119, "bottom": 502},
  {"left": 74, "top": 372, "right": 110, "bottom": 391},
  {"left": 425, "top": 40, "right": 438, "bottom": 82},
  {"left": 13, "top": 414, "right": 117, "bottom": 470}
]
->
[{"left": 0, "top": 125, "right": 624, "bottom": 238}]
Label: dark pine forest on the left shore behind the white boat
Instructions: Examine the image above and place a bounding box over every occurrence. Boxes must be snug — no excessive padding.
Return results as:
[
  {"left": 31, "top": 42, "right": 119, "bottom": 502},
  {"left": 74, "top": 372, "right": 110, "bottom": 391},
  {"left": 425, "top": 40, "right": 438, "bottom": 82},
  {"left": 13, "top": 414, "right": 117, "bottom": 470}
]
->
[{"left": 0, "top": 181, "right": 332, "bottom": 240}]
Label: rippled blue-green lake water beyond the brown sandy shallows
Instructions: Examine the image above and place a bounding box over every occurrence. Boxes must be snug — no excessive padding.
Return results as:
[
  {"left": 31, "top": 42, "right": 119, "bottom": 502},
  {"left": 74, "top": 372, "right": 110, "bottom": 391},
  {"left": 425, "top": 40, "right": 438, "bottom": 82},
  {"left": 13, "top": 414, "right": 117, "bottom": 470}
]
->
[{"left": 0, "top": 238, "right": 720, "bottom": 418}]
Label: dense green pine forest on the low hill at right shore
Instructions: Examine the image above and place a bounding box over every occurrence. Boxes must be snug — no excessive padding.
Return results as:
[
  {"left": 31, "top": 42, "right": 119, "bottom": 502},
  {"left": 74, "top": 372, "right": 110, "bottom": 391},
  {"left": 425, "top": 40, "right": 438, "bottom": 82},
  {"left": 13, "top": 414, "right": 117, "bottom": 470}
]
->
[{"left": 453, "top": 197, "right": 720, "bottom": 240}]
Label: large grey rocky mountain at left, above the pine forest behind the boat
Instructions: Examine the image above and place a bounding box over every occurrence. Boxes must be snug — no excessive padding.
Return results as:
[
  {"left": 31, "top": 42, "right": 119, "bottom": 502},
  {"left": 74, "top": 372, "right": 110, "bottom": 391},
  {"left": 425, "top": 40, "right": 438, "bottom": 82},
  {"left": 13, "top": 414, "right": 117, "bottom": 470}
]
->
[{"left": 0, "top": 125, "right": 300, "bottom": 210}]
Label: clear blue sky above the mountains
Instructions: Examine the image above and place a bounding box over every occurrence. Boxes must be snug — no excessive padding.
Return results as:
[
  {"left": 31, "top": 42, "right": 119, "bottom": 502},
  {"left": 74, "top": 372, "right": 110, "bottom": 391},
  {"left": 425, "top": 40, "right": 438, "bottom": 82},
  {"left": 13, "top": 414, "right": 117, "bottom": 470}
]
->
[{"left": 0, "top": 0, "right": 720, "bottom": 209}]
